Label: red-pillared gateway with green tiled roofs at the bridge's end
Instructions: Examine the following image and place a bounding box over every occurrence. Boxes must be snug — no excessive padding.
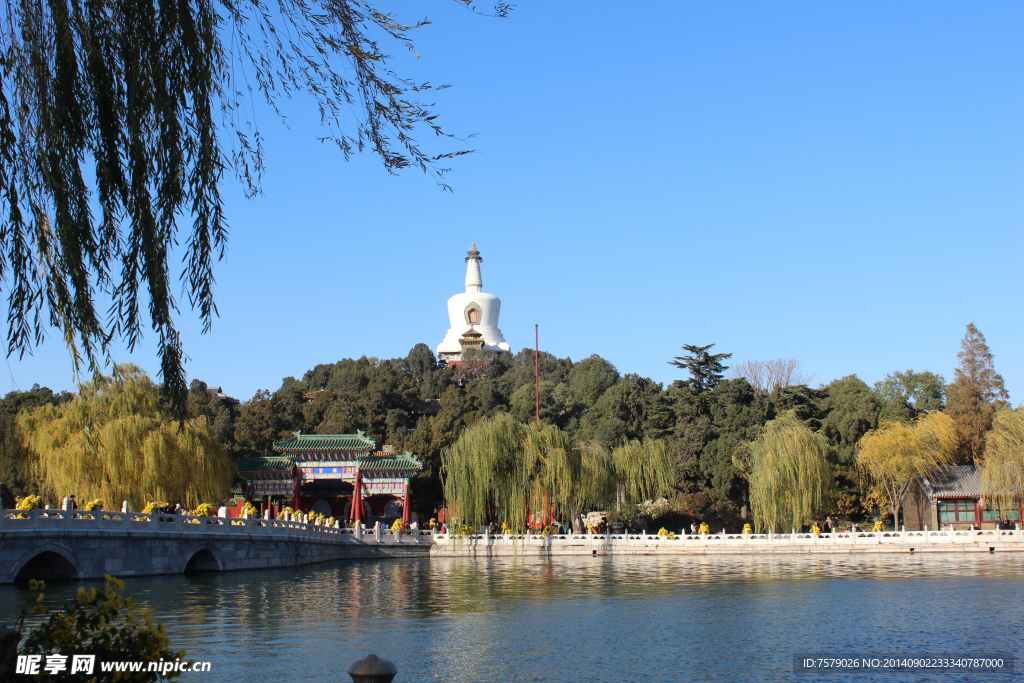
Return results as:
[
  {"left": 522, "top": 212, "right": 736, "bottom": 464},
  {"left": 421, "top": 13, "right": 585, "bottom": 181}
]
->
[{"left": 239, "top": 431, "right": 423, "bottom": 524}]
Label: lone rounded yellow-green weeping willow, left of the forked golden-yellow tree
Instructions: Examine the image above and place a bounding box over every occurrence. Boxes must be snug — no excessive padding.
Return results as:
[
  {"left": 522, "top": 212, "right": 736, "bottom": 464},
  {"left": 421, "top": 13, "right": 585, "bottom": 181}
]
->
[{"left": 750, "top": 413, "right": 836, "bottom": 531}]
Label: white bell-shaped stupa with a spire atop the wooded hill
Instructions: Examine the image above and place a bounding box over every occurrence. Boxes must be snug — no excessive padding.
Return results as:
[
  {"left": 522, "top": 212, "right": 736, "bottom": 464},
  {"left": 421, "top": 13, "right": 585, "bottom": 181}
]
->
[{"left": 437, "top": 242, "right": 510, "bottom": 362}]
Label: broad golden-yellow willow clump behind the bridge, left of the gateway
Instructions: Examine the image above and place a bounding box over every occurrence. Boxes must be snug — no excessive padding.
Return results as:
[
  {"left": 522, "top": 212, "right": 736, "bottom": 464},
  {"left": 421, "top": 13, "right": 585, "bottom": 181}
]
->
[{"left": 17, "top": 365, "right": 234, "bottom": 510}]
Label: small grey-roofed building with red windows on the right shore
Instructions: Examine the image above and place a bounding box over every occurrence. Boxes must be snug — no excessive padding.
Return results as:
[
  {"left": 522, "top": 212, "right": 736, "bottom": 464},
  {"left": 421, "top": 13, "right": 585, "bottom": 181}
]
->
[{"left": 902, "top": 465, "right": 1021, "bottom": 530}]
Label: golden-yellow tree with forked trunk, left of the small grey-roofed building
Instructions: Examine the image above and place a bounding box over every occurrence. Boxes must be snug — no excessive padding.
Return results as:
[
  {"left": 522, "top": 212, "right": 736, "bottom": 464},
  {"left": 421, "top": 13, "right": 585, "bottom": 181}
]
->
[{"left": 857, "top": 411, "right": 959, "bottom": 528}]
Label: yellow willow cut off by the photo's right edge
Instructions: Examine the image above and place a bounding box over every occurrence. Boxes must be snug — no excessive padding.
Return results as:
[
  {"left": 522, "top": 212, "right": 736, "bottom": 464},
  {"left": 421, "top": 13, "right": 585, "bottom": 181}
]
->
[{"left": 980, "top": 407, "right": 1024, "bottom": 510}]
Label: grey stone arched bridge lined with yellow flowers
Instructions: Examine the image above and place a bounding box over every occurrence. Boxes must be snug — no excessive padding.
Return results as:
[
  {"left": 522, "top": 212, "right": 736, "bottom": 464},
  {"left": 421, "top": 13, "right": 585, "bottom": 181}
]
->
[{"left": 0, "top": 509, "right": 433, "bottom": 584}]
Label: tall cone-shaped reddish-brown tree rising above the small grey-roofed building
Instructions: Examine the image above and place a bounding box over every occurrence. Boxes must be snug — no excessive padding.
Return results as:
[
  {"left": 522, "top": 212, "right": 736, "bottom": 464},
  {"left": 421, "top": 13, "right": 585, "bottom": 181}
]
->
[{"left": 946, "top": 323, "right": 1010, "bottom": 464}]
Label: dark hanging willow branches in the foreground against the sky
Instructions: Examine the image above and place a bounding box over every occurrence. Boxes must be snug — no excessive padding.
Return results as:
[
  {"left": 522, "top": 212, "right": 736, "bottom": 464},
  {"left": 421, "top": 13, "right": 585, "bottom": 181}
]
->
[{"left": 0, "top": 0, "right": 509, "bottom": 415}]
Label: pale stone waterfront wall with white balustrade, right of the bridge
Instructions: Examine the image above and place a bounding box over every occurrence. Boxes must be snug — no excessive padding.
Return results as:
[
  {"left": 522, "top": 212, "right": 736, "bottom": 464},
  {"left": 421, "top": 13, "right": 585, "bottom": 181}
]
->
[{"left": 430, "top": 529, "right": 1024, "bottom": 557}]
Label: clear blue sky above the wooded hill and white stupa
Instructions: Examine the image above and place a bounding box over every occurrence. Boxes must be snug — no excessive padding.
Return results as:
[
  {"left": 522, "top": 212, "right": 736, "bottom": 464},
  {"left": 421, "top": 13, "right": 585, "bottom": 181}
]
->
[{"left": 3, "top": 1, "right": 1024, "bottom": 403}]
